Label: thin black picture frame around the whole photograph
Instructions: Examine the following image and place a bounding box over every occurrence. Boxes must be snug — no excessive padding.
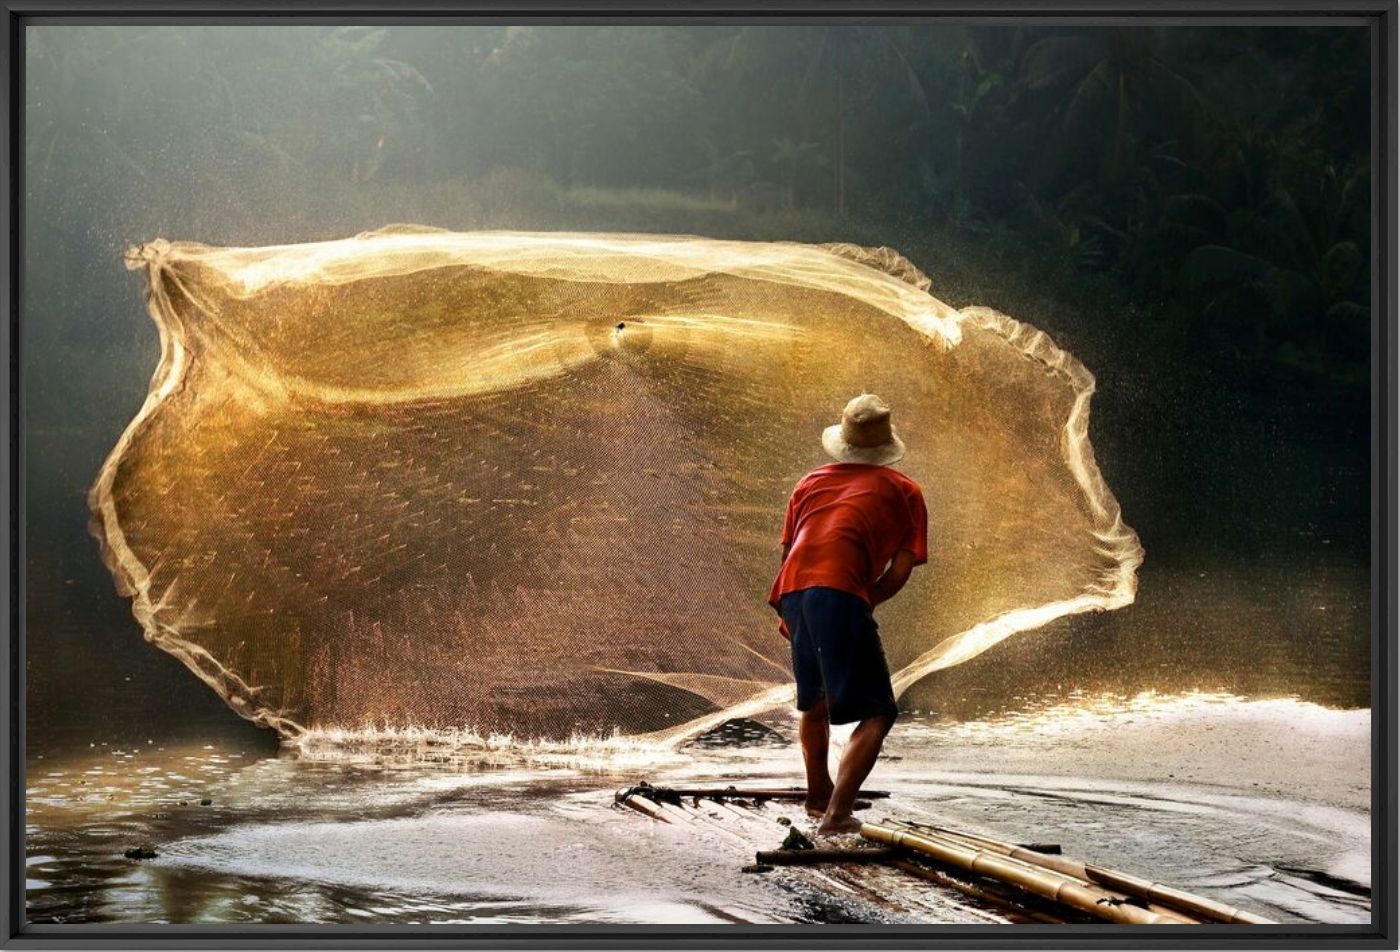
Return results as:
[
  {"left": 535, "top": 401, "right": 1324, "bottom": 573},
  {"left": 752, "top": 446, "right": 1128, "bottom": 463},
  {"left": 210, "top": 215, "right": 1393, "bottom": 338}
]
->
[{"left": 0, "top": 0, "right": 1400, "bottom": 949}]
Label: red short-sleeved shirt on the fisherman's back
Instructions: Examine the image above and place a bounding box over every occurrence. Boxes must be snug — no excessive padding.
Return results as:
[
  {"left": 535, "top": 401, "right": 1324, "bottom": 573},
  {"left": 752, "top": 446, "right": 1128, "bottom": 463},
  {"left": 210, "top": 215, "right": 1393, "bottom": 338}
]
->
[{"left": 769, "top": 463, "right": 928, "bottom": 608}]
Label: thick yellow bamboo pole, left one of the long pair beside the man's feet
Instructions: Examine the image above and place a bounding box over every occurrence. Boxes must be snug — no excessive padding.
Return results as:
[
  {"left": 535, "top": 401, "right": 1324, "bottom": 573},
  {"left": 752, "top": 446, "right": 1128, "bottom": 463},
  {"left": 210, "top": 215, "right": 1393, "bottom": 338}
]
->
[{"left": 861, "top": 823, "right": 1193, "bottom": 925}]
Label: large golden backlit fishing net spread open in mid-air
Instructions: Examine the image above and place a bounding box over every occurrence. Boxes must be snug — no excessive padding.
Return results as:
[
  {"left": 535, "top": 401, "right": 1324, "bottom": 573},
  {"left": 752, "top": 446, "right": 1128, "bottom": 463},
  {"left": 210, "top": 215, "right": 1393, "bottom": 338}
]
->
[{"left": 90, "top": 227, "right": 1141, "bottom": 738}]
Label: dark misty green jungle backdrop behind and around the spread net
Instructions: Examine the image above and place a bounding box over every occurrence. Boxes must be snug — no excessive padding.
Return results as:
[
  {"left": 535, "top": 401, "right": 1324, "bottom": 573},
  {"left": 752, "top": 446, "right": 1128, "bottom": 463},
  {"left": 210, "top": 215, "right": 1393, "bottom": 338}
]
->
[{"left": 22, "top": 25, "right": 1372, "bottom": 744}]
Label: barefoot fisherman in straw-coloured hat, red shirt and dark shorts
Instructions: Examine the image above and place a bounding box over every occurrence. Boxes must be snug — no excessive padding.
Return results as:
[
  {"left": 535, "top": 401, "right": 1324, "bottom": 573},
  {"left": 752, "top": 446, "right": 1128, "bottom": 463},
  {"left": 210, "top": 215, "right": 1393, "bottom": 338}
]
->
[{"left": 769, "top": 393, "right": 928, "bottom": 834}]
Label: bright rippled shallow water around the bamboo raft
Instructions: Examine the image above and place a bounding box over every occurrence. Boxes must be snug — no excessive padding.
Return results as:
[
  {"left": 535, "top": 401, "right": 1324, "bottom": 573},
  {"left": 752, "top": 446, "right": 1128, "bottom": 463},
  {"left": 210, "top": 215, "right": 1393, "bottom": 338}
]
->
[{"left": 27, "top": 693, "right": 1371, "bottom": 923}]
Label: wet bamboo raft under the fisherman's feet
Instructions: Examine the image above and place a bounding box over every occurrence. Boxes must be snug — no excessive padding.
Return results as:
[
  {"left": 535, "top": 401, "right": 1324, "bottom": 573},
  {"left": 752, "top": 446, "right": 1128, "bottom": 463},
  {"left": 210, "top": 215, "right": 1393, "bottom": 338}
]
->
[{"left": 615, "top": 784, "right": 1271, "bottom": 925}]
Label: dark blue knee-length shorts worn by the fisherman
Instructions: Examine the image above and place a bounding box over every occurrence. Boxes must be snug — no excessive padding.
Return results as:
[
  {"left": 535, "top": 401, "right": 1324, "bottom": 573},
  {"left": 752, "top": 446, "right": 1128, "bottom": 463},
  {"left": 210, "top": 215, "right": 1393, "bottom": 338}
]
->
[{"left": 778, "top": 588, "right": 899, "bottom": 724}]
